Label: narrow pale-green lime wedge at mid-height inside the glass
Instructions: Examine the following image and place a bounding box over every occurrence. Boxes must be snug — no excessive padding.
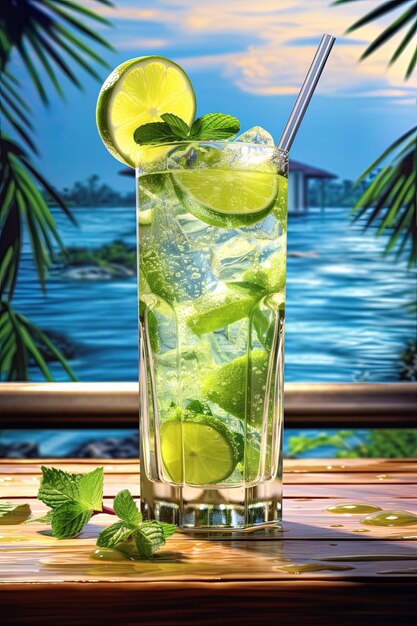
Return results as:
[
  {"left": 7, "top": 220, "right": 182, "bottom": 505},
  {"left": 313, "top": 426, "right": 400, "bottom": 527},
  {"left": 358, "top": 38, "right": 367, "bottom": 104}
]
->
[{"left": 187, "top": 289, "right": 258, "bottom": 335}]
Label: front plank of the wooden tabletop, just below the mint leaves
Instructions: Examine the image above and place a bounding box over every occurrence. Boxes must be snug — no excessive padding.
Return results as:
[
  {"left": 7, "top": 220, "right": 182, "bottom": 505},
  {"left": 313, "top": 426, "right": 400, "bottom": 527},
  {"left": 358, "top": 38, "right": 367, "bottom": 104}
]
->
[{"left": 0, "top": 533, "right": 417, "bottom": 590}]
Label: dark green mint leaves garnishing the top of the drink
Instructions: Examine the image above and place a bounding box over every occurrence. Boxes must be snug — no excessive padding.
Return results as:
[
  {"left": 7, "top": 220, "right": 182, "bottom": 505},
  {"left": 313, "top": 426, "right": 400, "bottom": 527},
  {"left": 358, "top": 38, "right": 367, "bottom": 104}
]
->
[{"left": 133, "top": 113, "right": 240, "bottom": 146}]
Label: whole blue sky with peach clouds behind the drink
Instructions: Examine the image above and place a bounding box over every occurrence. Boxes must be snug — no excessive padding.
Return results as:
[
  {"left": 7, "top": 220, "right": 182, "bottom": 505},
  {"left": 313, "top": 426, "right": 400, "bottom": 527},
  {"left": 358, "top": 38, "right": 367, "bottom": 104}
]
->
[{"left": 10, "top": 0, "right": 417, "bottom": 191}]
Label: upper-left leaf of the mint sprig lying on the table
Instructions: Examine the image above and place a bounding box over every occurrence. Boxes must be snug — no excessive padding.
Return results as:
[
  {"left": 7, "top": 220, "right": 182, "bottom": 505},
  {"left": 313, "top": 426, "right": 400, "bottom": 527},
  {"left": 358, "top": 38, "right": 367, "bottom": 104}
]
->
[{"left": 37, "top": 466, "right": 83, "bottom": 509}]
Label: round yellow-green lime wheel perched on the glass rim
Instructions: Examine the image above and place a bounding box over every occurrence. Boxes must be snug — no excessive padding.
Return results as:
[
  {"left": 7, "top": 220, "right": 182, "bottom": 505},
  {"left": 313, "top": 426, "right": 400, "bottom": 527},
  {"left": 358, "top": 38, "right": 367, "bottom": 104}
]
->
[{"left": 96, "top": 56, "right": 196, "bottom": 167}]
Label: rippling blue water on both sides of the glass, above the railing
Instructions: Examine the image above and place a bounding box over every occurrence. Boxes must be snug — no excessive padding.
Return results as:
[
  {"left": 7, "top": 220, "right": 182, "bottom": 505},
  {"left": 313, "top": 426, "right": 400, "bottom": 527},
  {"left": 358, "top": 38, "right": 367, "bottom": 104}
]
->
[{"left": 14, "top": 208, "right": 416, "bottom": 382}]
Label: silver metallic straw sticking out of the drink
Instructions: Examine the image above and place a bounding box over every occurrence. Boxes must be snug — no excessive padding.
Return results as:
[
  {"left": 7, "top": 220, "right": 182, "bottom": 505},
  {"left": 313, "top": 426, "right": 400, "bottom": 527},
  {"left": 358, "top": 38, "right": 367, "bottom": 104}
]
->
[{"left": 278, "top": 35, "right": 336, "bottom": 151}]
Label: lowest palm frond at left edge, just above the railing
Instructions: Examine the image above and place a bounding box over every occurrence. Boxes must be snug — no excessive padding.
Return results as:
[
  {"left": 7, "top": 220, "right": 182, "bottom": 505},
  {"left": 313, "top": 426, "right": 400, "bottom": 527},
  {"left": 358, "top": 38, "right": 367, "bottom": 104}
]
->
[{"left": 0, "top": 301, "right": 77, "bottom": 381}]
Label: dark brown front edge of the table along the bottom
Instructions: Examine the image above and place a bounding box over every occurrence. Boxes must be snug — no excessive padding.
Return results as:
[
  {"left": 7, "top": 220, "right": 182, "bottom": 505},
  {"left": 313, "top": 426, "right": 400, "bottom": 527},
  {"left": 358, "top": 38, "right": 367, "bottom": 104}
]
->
[{"left": 0, "top": 579, "right": 416, "bottom": 626}]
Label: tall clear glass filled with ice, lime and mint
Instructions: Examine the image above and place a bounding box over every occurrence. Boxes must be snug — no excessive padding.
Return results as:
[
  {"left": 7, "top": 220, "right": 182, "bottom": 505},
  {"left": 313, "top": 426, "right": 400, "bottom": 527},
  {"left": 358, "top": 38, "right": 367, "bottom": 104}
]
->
[{"left": 136, "top": 141, "right": 288, "bottom": 533}]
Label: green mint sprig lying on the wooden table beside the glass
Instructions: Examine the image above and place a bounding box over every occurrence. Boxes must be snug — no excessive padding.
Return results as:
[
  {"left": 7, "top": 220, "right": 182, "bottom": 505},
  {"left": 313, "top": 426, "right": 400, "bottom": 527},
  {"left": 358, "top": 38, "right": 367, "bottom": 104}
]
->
[{"left": 19, "top": 466, "right": 177, "bottom": 559}]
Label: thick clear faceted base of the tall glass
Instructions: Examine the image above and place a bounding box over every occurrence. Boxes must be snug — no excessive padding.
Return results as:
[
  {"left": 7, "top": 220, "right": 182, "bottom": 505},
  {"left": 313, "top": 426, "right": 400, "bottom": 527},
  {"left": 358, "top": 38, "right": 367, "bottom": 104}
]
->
[{"left": 141, "top": 474, "right": 282, "bottom": 538}]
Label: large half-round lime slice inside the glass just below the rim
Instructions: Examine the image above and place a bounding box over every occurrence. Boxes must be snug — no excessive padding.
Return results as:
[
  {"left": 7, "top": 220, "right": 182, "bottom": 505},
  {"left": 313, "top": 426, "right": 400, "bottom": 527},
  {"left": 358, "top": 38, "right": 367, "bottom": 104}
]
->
[{"left": 171, "top": 169, "right": 279, "bottom": 228}]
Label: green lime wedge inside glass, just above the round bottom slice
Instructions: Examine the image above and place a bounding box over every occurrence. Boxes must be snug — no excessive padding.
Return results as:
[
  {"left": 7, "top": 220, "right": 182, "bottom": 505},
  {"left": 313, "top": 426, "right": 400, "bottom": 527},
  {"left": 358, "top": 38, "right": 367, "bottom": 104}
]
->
[{"left": 203, "top": 349, "right": 269, "bottom": 423}]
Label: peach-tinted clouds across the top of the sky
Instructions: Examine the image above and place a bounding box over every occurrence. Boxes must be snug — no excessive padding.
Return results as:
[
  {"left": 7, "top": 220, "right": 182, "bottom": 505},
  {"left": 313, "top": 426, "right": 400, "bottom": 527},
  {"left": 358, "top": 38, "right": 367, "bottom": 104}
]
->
[{"left": 91, "top": 0, "right": 417, "bottom": 100}]
